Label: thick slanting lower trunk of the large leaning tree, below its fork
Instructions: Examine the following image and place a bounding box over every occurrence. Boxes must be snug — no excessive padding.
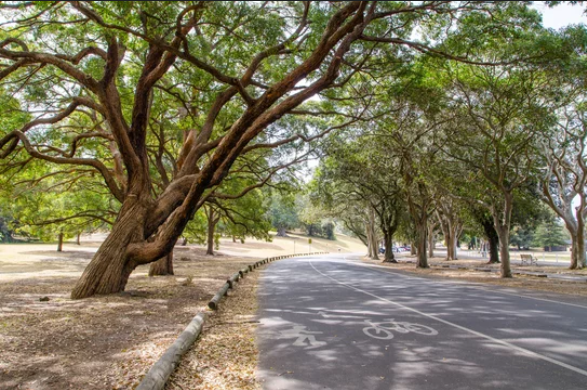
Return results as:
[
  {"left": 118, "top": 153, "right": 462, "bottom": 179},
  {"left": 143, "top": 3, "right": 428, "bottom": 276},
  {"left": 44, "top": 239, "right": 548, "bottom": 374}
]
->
[{"left": 71, "top": 197, "right": 147, "bottom": 299}]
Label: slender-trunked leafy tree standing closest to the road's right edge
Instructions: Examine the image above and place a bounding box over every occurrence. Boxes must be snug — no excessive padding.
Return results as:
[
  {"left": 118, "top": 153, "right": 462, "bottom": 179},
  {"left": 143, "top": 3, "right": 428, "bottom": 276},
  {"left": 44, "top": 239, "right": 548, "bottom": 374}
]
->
[{"left": 443, "top": 67, "right": 552, "bottom": 278}]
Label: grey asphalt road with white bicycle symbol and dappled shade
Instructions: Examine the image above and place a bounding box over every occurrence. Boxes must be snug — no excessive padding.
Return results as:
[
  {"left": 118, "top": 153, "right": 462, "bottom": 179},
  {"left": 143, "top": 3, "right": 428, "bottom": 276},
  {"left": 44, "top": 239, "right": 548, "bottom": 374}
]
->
[{"left": 258, "top": 255, "right": 587, "bottom": 390}]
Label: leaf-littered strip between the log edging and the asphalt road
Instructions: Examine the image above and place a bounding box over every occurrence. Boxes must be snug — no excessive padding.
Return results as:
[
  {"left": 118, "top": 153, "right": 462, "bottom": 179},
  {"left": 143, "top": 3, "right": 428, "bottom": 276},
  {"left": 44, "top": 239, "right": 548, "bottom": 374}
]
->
[{"left": 165, "top": 272, "right": 261, "bottom": 390}]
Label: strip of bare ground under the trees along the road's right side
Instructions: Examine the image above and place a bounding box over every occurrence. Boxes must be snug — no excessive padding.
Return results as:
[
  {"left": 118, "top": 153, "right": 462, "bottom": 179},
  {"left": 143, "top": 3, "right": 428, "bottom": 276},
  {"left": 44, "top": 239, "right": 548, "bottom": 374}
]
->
[{"left": 363, "top": 257, "right": 587, "bottom": 297}]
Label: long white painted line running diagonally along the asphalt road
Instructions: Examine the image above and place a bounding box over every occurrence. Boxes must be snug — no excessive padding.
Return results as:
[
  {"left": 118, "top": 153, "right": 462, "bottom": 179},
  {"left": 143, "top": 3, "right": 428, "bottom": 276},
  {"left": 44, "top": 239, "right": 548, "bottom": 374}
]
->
[{"left": 308, "top": 260, "right": 587, "bottom": 376}]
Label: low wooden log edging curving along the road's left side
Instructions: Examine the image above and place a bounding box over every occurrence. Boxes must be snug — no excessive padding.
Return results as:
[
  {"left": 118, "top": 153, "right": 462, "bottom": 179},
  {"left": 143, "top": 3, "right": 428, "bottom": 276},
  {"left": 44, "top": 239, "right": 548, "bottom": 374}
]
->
[{"left": 136, "top": 252, "right": 328, "bottom": 390}]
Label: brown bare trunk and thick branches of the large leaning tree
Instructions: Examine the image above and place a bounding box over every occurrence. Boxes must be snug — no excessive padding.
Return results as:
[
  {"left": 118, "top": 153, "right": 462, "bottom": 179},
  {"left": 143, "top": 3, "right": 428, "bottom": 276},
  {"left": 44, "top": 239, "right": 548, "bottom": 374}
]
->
[{"left": 63, "top": 2, "right": 376, "bottom": 299}]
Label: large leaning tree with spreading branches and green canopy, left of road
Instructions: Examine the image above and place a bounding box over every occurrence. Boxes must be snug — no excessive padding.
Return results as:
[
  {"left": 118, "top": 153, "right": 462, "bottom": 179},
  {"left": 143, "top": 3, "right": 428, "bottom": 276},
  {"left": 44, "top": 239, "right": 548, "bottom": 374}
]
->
[{"left": 0, "top": 1, "right": 552, "bottom": 298}]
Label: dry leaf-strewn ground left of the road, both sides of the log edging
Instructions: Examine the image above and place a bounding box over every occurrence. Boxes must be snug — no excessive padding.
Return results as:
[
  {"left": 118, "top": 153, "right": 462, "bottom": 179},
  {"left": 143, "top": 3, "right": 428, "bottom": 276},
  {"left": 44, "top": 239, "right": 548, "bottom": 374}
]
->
[{"left": 0, "top": 235, "right": 363, "bottom": 390}]
